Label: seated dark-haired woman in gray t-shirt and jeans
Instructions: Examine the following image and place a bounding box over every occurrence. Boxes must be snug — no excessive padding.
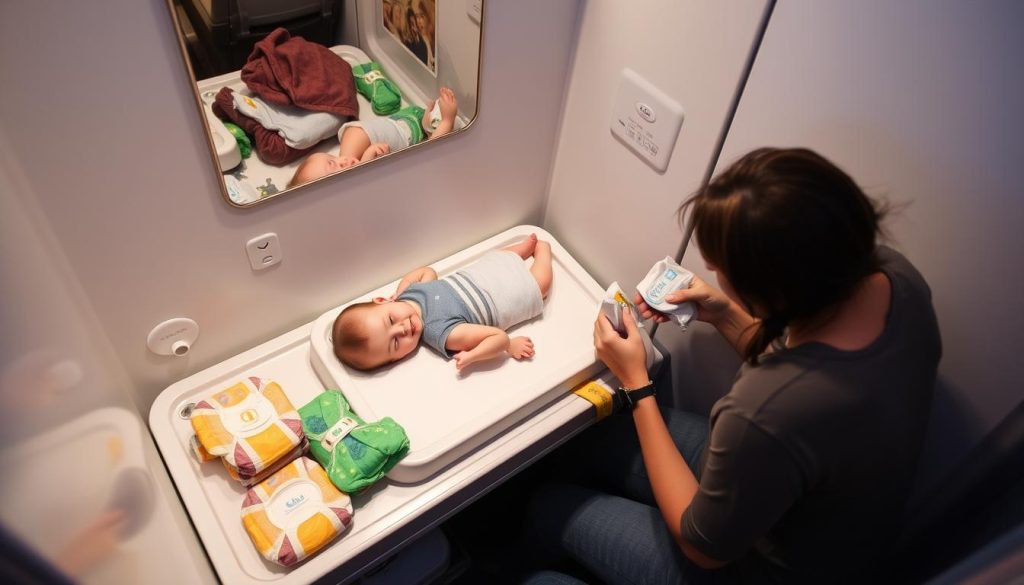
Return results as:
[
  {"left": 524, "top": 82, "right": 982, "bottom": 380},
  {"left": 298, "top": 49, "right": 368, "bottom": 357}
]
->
[{"left": 531, "top": 149, "right": 941, "bottom": 583}]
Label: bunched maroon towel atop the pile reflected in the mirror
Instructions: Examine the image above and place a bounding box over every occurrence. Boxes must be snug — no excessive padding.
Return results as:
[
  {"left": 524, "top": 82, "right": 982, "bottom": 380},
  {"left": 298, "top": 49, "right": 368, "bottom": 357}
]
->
[{"left": 242, "top": 28, "right": 359, "bottom": 118}]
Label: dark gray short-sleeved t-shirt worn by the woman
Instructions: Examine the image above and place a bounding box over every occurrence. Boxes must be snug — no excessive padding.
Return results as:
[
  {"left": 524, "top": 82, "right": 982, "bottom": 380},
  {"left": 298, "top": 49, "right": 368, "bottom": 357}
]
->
[{"left": 682, "top": 248, "right": 942, "bottom": 582}]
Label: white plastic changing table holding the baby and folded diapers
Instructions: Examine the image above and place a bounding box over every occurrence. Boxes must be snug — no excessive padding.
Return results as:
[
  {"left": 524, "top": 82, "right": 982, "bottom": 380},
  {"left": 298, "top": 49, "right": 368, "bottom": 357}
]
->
[{"left": 150, "top": 225, "right": 634, "bottom": 584}]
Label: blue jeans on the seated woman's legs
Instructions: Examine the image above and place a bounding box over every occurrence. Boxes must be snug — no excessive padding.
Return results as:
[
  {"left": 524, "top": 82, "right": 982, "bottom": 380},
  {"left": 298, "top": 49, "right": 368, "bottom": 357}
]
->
[{"left": 527, "top": 408, "right": 727, "bottom": 584}]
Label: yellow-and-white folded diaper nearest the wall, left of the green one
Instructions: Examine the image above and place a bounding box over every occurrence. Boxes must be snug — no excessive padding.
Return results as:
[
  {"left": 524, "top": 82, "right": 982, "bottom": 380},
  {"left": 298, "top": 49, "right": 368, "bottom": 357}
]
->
[{"left": 191, "top": 377, "right": 306, "bottom": 485}]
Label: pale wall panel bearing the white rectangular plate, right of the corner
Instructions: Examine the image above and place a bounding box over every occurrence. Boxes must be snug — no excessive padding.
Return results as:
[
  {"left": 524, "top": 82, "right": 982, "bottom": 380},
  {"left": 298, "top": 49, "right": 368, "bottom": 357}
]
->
[{"left": 545, "top": 0, "right": 765, "bottom": 405}]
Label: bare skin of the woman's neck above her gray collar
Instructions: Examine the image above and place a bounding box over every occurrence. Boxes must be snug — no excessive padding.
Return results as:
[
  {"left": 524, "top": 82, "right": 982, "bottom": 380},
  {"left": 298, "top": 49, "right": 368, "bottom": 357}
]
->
[{"left": 785, "top": 273, "right": 892, "bottom": 351}]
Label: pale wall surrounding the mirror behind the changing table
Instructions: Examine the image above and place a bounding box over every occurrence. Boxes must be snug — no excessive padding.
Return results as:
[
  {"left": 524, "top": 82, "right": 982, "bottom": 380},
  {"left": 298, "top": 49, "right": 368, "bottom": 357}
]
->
[{"left": 0, "top": 0, "right": 578, "bottom": 413}]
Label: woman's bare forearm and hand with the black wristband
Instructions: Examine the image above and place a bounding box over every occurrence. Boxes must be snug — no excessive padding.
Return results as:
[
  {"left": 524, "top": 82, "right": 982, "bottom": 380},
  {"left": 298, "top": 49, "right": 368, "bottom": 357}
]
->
[{"left": 594, "top": 310, "right": 725, "bottom": 569}]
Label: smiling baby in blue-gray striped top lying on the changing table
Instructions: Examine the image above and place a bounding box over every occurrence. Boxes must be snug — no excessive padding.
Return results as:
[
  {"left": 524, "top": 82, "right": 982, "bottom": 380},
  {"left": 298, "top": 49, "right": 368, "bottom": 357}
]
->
[{"left": 332, "top": 234, "right": 551, "bottom": 371}]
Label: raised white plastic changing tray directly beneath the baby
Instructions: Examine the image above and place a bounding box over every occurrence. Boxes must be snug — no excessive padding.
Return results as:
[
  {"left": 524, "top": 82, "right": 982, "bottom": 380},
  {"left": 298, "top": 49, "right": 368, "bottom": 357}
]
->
[{"left": 310, "top": 225, "right": 604, "bottom": 483}]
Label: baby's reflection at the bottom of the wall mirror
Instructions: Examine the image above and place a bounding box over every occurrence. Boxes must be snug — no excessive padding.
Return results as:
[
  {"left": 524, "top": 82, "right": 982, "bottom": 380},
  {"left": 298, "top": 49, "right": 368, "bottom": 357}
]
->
[{"left": 288, "top": 87, "right": 459, "bottom": 186}]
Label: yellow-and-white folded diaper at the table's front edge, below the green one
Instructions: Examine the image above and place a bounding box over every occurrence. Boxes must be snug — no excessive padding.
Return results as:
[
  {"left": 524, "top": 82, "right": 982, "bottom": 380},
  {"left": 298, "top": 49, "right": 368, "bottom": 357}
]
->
[{"left": 242, "top": 457, "right": 352, "bottom": 567}]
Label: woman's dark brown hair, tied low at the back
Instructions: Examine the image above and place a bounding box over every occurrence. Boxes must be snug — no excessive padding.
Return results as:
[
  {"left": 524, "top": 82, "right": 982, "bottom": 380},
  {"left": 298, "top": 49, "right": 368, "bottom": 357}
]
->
[{"left": 680, "top": 149, "right": 885, "bottom": 365}]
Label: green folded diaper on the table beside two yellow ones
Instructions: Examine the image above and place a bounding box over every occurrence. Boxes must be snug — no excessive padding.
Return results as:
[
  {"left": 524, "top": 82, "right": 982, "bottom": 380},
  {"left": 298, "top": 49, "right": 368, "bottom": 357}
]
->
[{"left": 299, "top": 390, "right": 409, "bottom": 494}]
